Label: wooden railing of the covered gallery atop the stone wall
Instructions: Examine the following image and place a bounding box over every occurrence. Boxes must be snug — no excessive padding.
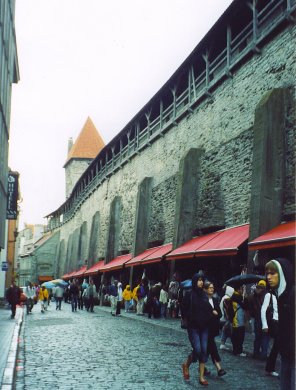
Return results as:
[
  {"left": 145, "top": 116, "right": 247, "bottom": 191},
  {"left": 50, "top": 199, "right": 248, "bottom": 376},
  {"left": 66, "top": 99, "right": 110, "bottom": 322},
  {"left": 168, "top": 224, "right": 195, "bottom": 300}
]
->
[{"left": 48, "top": 0, "right": 296, "bottom": 230}]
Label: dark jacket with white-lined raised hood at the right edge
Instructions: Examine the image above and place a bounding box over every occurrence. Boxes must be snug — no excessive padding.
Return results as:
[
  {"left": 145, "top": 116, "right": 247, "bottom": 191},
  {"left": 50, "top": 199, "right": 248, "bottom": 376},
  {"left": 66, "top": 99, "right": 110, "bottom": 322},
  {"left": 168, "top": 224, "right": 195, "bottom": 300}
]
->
[{"left": 272, "top": 258, "right": 295, "bottom": 362}]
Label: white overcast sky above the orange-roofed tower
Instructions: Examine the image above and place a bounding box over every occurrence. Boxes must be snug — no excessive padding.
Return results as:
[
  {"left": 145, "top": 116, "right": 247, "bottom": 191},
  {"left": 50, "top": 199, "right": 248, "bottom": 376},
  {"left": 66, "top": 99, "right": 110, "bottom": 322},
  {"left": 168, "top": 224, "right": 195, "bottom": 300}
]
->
[{"left": 9, "top": 0, "right": 231, "bottom": 229}]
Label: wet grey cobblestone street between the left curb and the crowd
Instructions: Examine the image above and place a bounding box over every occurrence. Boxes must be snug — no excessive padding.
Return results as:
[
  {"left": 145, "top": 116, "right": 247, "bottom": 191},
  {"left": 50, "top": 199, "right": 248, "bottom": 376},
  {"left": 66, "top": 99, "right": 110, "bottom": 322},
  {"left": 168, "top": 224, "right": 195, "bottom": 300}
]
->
[{"left": 14, "top": 304, "right": 279, "bottom": 390}]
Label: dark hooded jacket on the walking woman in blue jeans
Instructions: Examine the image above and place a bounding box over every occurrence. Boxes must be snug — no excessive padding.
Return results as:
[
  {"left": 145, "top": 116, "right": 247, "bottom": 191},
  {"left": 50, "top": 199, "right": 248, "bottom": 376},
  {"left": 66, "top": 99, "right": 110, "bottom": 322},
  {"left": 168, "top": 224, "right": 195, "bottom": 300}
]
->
[{"left": 183, "top": 273, "right": 214, "bottom": 330}]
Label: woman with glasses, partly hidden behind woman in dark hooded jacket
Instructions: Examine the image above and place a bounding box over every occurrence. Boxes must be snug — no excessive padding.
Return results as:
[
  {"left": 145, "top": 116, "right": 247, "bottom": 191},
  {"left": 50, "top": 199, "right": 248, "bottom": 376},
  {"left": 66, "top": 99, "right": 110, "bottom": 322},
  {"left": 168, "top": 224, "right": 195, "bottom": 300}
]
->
[{"left": 204, "top": 281, "right": 226, "bottom": 376}]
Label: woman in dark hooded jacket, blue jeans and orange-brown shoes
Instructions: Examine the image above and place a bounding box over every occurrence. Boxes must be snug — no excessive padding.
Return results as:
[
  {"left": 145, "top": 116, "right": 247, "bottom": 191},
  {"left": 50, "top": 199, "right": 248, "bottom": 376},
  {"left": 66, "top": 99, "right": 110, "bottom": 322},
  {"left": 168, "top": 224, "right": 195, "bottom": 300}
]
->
[{"left": 182, "top": 271, "right": 214, "bottom": 386}]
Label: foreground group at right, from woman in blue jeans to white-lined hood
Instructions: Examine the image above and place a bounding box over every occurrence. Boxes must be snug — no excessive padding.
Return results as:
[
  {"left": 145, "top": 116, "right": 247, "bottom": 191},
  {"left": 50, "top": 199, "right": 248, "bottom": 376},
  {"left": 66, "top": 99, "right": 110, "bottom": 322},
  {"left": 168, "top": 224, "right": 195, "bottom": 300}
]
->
[{"left": 181, "top": 259, "right": 295, "bottom": 390}]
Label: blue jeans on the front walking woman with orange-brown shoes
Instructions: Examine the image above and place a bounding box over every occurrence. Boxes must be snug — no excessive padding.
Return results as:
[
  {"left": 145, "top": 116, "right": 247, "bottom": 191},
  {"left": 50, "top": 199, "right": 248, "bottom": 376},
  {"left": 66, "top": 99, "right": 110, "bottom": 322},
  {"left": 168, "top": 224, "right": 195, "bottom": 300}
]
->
[{"left": 187, "top": 328, "right": 208, "bottom": 363}]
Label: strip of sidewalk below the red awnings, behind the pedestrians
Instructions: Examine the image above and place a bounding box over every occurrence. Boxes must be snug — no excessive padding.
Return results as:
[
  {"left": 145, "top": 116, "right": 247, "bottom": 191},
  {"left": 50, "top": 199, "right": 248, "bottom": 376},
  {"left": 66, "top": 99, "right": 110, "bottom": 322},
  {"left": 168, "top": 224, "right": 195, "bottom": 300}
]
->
[{"left": 94, "top": 306, "right": 254, "bottom": 356}]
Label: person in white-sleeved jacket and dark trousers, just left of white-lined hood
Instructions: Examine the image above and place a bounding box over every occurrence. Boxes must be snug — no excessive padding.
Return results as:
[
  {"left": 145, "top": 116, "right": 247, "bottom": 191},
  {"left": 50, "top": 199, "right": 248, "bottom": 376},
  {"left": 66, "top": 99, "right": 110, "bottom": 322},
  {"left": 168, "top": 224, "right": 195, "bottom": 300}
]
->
[{"left": 261, "top": 284, "right": 279, "bottom": 377}]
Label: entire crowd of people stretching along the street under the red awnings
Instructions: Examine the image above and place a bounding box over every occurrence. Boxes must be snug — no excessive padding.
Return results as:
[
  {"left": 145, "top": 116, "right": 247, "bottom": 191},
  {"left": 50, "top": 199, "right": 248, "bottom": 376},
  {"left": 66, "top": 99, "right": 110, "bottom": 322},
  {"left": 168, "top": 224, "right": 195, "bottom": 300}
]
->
[{"left": 6, "top": 259, "right": 295, "bottom": 390}]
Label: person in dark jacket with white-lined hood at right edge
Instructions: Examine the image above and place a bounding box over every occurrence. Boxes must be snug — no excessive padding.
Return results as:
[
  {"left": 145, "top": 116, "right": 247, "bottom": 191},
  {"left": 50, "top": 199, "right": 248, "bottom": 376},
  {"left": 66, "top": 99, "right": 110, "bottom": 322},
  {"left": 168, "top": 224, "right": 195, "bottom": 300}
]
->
[{"left": 265, "top": 258, "right": 295, "bottom": 390}]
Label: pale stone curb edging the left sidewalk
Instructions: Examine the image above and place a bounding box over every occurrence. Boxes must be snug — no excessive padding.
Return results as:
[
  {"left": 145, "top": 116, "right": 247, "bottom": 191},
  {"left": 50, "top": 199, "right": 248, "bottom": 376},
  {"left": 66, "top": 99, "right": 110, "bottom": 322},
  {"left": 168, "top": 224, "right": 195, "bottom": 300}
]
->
[{"left": 1, "top": 307, "right": 24, "bottom": 390}]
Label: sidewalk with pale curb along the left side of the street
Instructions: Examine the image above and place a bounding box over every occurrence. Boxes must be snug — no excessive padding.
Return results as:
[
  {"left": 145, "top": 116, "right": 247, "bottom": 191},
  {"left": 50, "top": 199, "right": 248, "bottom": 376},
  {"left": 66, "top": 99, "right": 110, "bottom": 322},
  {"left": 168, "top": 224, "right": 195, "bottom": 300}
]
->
[{"left": 0, "top": 307, "right": 23, "bottom": 390}]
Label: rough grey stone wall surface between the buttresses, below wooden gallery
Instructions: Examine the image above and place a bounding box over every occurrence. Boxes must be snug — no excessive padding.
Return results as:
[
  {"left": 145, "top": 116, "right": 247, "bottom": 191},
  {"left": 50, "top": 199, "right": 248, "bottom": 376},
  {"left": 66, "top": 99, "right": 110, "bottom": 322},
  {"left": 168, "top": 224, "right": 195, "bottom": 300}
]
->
[{"left": 55, "top": 25, "right": 296, "bottom": 270}]
